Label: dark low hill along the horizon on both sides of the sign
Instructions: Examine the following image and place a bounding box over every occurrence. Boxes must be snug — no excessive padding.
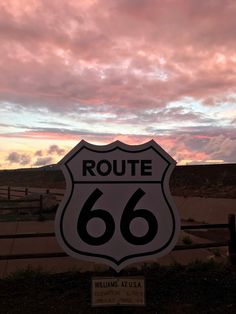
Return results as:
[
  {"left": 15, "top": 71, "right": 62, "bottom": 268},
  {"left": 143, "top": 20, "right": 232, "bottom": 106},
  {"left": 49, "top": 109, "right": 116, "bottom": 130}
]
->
[{"left": 0, "top": 164, "right": 236, "bottom": 198}]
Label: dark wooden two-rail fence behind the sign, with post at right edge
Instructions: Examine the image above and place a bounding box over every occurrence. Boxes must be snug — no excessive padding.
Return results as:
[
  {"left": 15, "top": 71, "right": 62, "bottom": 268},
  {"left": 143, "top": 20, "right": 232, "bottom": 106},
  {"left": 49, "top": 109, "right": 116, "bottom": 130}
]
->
[{"left": 0, "top": 214, "right": 236, "bottom": 265}]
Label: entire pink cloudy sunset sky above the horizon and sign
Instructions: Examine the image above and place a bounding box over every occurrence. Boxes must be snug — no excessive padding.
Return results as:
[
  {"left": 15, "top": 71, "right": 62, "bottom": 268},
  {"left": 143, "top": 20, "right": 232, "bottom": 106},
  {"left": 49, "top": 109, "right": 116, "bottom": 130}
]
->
[{"left": 0, "top": 0, "right": 236, "bottom": 169}]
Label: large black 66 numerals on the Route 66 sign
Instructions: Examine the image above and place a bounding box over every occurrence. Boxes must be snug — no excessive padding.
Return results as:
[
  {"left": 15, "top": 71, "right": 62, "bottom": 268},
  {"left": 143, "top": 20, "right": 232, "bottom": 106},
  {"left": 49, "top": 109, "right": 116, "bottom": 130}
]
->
[{"left": 77, "top": 188, "right": 158, "bottom": 245}]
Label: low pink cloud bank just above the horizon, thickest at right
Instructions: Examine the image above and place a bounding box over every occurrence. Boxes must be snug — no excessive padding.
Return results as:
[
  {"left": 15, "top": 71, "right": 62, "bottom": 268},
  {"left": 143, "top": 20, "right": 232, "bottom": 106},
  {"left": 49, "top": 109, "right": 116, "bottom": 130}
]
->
[{"left": 2, "top": 120, "right": 236, "bottom": 165}]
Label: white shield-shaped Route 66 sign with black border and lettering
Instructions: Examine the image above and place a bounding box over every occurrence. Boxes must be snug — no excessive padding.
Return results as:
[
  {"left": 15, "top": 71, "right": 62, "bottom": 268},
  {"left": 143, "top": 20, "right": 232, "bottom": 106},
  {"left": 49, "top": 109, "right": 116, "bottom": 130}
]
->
[{"left": 55, "top": 141, "right": 180, "bottom": 271}]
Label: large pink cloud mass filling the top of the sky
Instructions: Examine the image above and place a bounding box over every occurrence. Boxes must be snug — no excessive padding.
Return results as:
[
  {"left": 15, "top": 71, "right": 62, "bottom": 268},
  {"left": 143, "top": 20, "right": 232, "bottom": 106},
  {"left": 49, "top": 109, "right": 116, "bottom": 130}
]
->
[{"left": 0, "top": 0, "right": 236, "bottom": 112}]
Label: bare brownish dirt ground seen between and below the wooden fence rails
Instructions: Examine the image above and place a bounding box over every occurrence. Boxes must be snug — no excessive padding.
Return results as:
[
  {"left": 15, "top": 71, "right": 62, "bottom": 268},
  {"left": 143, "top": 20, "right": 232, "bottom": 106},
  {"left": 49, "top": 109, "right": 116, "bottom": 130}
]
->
[{"left": 0, "top": 197, "right": 236, "bottom": 277}]
